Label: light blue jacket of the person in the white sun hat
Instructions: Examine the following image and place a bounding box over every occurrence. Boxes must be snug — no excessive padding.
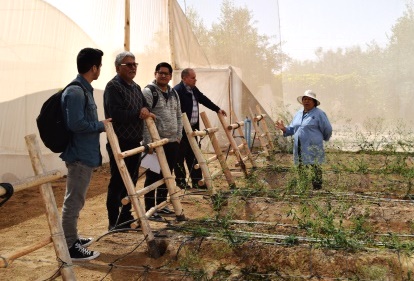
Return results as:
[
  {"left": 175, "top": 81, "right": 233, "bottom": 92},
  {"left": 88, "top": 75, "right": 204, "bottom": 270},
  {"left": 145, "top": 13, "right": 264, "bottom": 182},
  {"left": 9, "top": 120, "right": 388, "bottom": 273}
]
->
[{"left": 283, "top": 107, "right": 332, "bottom": 164}]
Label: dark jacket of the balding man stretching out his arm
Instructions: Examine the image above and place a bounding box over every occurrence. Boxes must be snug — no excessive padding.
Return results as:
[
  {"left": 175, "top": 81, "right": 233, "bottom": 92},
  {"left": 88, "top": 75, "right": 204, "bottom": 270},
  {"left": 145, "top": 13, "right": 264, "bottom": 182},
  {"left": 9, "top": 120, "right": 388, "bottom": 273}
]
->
[{"left": 174, "top": 81, "right": 220, "bottom": 129}]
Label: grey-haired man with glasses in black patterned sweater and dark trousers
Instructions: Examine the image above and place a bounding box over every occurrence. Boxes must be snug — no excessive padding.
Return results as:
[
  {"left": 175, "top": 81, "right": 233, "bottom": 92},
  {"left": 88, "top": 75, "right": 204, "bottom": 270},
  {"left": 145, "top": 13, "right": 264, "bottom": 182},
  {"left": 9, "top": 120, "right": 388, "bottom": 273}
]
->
[{"left": 104, "top": 51, "right": 151, "bottom": 230}]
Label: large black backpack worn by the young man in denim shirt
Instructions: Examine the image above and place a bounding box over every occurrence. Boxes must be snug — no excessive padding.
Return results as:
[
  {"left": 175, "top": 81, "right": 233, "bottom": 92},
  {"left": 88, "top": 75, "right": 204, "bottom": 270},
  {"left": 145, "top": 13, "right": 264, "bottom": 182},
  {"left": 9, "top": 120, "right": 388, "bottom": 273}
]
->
[{"left": 36, "top": 82, "right": 88, "bottom": 152}]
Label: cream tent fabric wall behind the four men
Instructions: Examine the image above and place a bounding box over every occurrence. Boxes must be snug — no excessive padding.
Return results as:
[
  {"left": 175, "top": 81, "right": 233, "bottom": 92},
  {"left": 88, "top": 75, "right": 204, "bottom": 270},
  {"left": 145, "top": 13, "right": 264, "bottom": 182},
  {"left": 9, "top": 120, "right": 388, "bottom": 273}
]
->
[{"left": 0, "top": 0, "right": 272, "bottom": 182}]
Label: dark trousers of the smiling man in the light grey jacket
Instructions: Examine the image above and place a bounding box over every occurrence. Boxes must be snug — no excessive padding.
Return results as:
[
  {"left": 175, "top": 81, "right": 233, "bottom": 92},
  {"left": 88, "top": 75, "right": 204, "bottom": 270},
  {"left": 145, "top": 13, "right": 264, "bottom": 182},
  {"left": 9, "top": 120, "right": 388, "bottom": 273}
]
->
[{"left": 144, "top": 142, "right": 179, "bottom": 211}]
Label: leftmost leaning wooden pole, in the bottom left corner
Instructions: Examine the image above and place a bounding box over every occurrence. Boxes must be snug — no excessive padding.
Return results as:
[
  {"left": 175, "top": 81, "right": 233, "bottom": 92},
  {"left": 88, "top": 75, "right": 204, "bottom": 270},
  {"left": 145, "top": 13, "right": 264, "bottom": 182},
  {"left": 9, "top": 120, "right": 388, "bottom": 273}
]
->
[{"left": 25, "top": 134, "right": 76, "bottom": 280}]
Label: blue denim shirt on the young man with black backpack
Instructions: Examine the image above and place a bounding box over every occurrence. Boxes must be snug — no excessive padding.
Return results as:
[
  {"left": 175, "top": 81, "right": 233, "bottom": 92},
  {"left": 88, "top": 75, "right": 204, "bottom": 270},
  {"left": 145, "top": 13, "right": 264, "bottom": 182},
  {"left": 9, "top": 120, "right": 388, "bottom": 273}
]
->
[{"left": 60, "top": 74, "right": 105, "bottom": 167}]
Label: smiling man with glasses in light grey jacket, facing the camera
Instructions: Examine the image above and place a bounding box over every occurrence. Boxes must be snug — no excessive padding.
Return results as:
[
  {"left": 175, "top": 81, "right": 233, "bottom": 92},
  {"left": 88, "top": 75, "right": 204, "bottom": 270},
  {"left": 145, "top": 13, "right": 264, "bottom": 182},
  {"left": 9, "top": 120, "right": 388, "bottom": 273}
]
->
[{"left": 142, "top": 62, "right": 183, "bottom": 220}]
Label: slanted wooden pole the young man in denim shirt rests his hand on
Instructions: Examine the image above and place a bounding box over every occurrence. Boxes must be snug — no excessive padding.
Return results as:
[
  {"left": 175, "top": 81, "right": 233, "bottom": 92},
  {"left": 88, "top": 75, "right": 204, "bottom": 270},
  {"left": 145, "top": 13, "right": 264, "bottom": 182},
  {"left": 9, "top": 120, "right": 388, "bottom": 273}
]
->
[{"left": 105, "top": 123, "right": 161, "bottom": 258}]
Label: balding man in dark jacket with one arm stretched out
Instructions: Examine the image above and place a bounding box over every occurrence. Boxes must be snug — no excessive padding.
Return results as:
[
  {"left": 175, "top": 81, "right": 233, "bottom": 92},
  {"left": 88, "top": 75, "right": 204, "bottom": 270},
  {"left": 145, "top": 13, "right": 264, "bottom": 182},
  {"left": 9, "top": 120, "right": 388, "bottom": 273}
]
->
[{"left": 174, "top": 68, "right": 227, "bottom": 188}]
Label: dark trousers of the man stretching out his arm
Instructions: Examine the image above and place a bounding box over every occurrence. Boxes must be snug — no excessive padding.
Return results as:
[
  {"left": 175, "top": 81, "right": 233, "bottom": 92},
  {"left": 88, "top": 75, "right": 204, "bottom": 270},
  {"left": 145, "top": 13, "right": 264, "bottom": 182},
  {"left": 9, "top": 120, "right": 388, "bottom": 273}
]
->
[{"left": 174, "top": 130, "right": 203, "bottom": 188}]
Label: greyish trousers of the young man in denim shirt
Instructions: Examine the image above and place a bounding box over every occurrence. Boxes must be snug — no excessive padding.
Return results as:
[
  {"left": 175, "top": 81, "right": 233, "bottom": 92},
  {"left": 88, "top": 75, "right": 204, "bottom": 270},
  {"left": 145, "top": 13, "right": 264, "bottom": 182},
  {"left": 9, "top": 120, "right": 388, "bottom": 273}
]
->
[{"left": 62, "top": 161, "right": 94, "bottom": 248}]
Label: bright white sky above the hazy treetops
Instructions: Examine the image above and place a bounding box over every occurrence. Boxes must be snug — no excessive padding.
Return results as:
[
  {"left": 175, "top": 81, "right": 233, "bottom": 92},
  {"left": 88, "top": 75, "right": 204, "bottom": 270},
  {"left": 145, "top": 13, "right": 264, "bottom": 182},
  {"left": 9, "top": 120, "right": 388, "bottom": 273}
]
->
[{"left": 177, "top": 0, "right": 412, "bottom": 60}]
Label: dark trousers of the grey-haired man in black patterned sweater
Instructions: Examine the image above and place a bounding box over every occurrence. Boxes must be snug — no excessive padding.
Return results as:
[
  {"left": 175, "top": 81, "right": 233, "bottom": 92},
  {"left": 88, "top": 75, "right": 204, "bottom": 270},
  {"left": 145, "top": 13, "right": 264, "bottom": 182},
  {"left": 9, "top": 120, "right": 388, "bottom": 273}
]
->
[{"left": 106, "top": 142, "right": 141, "bottom": 226}]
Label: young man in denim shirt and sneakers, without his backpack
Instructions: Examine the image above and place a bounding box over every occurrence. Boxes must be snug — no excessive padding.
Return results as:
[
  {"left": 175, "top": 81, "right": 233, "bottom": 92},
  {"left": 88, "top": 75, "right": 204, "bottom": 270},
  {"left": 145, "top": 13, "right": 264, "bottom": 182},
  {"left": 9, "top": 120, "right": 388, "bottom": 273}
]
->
[{"left": 60, "top": 48, "right": 111, "bottom": 260}]
